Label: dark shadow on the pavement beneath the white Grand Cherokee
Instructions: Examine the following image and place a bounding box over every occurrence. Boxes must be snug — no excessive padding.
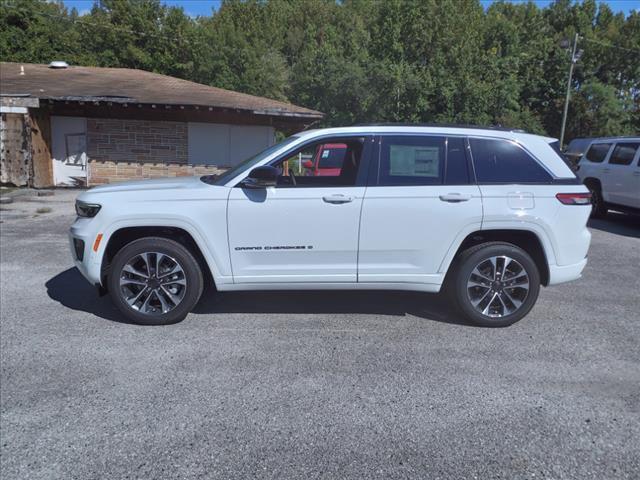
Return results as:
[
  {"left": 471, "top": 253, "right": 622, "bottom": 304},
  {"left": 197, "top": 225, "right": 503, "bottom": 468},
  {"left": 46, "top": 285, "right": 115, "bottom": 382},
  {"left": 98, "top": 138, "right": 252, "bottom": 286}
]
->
[{"left": 45, "top": 267, "right": 472, "bottom": 326}]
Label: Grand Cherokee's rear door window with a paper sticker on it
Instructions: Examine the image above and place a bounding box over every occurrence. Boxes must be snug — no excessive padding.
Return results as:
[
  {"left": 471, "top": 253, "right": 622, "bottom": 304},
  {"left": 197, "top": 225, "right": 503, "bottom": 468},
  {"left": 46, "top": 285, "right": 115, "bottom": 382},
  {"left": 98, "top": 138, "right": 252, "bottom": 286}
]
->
[{"left": 378, "top": 135, "right": 445, "bottom": 186}]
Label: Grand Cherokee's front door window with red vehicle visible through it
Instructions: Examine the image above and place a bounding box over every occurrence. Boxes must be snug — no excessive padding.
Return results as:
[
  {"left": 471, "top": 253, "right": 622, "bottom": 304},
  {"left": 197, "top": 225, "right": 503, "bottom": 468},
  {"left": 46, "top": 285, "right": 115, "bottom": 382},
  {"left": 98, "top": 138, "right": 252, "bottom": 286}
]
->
[{"left": 271, "top": 137, "right": 365, "bottom": 187}]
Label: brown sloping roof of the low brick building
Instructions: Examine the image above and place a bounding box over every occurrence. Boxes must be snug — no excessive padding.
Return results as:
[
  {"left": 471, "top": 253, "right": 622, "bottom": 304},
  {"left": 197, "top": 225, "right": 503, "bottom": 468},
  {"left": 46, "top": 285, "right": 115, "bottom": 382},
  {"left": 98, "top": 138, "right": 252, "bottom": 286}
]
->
[{"left": 0, "top": 62, "right": 323, "bottom": 119}]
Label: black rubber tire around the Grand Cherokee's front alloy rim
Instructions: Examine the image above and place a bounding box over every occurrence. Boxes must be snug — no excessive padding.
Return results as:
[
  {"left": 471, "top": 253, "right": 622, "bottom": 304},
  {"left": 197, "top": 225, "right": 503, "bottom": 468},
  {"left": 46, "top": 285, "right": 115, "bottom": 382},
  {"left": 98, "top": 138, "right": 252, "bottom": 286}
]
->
[{"left": 107, "top": 237, "right": 204, "bottom": 325}]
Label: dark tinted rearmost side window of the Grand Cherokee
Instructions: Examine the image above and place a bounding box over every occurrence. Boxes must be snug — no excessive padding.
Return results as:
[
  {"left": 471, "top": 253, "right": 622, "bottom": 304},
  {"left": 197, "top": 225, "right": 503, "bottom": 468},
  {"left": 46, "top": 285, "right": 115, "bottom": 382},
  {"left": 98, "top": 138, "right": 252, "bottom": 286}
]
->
[{"left": 469, "top": 138, "right": 553, "bottom": 183}]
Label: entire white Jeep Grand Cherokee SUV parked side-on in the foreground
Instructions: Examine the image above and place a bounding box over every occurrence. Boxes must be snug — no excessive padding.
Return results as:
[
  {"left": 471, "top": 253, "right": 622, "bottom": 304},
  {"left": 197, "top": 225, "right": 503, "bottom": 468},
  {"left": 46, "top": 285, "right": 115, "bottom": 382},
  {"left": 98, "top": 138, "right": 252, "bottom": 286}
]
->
[{"left": 70, "top": 125, "right": 591, "bottom": 326}]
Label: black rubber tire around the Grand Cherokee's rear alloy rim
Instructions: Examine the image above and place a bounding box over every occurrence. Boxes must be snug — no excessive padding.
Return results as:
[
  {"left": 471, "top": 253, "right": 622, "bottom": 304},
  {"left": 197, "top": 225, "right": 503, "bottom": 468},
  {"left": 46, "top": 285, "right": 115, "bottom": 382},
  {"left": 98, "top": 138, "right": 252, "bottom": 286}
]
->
[{"left": 448, "top": 242, "right": 540, "bottom": 327}]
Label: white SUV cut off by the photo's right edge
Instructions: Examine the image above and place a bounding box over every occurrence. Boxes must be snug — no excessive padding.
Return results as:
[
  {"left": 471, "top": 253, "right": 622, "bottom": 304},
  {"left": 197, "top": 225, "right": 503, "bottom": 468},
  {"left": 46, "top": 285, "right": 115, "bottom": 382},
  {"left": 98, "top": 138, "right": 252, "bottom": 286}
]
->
[{"left": 578, "top": 137, "right": 640, "bottom": 218}]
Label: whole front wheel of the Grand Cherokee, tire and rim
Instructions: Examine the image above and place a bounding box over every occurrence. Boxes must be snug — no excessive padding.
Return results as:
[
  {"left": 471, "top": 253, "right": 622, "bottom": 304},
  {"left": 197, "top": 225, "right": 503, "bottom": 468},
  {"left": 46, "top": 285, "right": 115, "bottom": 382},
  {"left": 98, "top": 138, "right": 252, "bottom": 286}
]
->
[{"left": 108, "top": 237, "right": 203, "bottom": 325}]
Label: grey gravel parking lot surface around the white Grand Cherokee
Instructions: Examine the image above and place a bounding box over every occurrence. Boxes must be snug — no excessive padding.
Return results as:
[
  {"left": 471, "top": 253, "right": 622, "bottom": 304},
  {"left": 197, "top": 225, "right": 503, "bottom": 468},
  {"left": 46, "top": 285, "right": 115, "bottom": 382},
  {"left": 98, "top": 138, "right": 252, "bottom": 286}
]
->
[{"left": 0, "top": 191, "right": 640, "bottom": 479}]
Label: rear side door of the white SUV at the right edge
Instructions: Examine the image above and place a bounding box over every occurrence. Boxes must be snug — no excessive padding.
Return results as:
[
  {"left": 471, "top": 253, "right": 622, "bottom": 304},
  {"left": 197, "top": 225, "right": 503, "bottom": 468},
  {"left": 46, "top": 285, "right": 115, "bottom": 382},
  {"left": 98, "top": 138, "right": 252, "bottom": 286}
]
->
[{"left": 604, "top": 142, "right": 640, "bottom": 207}]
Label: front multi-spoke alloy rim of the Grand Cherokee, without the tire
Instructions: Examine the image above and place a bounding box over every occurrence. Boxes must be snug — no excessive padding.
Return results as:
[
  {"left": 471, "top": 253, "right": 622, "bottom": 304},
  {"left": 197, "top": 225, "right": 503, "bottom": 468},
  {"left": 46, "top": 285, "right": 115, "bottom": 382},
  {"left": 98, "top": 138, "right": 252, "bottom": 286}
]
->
[{"left": 120, "top": 252, "right": 187, "bottom": 315}]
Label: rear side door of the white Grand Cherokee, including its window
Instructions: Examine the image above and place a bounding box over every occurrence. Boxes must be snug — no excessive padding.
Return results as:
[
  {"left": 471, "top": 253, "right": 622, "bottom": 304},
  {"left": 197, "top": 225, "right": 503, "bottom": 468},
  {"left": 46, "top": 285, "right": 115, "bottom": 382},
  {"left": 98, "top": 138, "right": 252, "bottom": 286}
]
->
[{"left": 358, "top": 134, "right": 482, "bottom": 285}]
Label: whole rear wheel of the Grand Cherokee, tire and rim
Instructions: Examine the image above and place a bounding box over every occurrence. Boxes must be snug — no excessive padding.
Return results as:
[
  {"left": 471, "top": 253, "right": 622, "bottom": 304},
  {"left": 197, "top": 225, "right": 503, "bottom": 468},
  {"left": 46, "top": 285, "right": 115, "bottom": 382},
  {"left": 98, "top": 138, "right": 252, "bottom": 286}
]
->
[{"left": 452, "top": 242, "right": 540, "bottom": 327}]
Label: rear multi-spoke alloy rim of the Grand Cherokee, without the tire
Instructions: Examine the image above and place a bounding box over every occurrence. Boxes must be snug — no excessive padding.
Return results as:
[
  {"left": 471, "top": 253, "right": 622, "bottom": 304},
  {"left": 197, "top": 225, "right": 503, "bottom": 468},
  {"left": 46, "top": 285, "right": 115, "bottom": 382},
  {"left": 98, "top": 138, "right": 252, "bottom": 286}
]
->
[{"left": 467, "top": 256, "right": 530, "bottom": 318}]
